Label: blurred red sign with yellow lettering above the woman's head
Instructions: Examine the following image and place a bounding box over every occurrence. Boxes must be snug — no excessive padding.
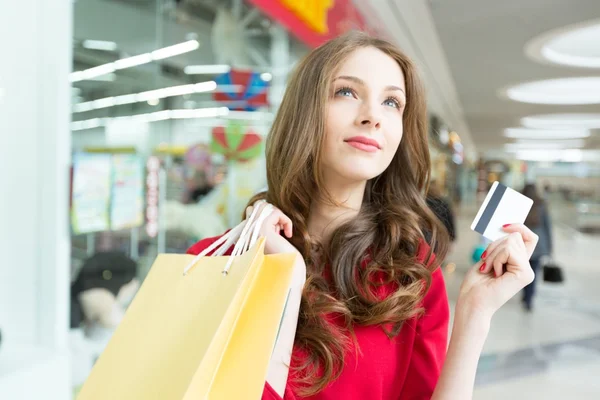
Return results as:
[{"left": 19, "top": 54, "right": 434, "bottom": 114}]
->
[{"left": 250, "top": 0, "right": 369, "bottom": 47}]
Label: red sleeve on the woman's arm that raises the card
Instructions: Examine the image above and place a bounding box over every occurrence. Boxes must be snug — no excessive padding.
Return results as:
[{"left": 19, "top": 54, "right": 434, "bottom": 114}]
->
[{"left": 400, "top": 268, "right": 450, "bottom": 400}]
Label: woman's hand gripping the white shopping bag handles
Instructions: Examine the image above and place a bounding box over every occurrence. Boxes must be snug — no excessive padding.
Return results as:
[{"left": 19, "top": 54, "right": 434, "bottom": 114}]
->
[{"left": 246, "top": 200, "right": 299, "bottom": 254}]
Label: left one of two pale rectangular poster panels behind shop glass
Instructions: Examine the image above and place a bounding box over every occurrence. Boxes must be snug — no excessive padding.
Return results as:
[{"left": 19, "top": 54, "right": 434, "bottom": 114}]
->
[{"left": 71, "top": 153, "right": 112, "bottom": 234}]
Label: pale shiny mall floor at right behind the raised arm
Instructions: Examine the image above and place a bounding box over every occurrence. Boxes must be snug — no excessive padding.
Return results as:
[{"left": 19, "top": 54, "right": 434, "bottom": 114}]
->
[{"left": 445, "top": 204, "right": 600, "bottom": 400}]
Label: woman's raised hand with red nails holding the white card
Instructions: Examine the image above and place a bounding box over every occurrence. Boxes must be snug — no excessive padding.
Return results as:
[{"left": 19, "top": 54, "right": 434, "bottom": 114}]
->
[{"left": 456, "top": 224, "right": 538, "bottom": 319}]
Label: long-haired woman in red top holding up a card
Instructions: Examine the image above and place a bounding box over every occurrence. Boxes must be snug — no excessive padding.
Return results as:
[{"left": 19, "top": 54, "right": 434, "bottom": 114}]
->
[{"left": 189, "top": 33, "right": 535, "bottom": 400}]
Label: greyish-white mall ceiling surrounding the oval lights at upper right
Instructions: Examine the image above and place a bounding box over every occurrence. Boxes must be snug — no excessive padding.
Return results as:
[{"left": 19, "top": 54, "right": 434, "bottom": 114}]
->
[{"left": 429, "top": 0, "right": 600, "bottom": 151}]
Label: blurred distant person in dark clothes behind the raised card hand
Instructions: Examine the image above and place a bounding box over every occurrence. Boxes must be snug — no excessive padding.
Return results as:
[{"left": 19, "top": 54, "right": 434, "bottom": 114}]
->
[{"left": 522, "top": 183, "right": 552, "bottom": 311}]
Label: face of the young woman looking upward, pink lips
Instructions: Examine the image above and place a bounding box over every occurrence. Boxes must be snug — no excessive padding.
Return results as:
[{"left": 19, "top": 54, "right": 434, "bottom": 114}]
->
[{"left": 322, "top": 47, "right": 406, "bottom": 183}]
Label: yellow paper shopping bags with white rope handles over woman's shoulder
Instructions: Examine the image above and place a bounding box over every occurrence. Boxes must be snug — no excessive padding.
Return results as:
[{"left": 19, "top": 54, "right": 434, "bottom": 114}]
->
[{"left": 78, "top": 239, "right": 295, "bottom": 400}]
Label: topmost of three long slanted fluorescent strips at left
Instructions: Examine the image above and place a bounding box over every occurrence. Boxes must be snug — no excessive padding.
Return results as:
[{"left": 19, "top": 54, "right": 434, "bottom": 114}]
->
[{"left": 70, "top": 40, "right": 200, "bottom": 82}]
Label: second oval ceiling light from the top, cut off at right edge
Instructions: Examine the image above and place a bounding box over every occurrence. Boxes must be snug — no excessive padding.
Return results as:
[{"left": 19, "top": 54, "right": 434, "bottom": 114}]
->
[{"left": 501, "top": 76, "right": 600, "bottom": 105}]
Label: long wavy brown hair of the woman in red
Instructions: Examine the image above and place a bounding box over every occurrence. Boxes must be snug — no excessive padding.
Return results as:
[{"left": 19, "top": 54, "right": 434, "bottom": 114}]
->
[{"left": 250, "top": 32, "right": 448, "bottom": 396}]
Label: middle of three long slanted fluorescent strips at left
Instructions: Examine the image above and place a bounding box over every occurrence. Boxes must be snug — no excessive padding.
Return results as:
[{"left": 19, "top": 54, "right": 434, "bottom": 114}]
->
[{"left": 73, "top": 81, "right": 217, "bottom": 113}]
